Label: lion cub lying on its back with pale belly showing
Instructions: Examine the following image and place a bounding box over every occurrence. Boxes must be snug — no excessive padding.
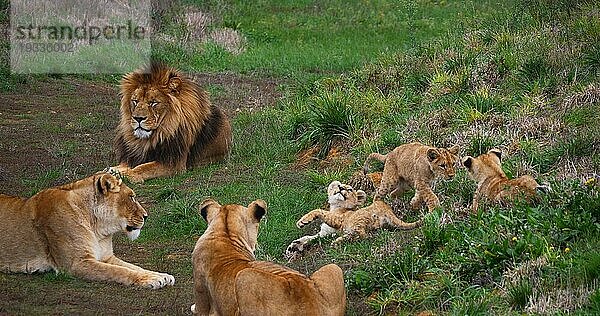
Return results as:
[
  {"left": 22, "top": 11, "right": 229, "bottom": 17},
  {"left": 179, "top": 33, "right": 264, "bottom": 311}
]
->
[{"left": 286, "top": 181, "right": 422, "bottom": 258}]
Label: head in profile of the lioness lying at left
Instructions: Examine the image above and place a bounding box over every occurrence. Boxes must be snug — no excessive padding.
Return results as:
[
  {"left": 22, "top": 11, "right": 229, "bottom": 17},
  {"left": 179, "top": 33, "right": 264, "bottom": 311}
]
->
[{"left": 94, "top": 172, "right": 148, "bottom": 240}]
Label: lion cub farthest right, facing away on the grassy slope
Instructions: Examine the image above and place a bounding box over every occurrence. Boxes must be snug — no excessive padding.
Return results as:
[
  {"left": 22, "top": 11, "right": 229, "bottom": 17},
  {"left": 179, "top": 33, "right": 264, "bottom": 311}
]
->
[{"left": 463, "top": 149, "right": 550, "bottom": 212}]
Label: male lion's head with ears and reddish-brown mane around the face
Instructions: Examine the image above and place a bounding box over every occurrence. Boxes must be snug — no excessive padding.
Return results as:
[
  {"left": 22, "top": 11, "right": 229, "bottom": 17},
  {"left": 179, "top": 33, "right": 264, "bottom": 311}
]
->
[{"left": 121, "top": 63, "right": 184, "bottom": 139}]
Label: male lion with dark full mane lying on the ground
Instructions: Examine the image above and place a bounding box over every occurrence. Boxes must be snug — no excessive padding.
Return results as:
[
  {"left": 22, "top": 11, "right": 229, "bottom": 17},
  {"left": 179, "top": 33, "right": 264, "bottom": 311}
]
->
[{"left": 115, "top": 63, "right": 231, "bottom": 182}]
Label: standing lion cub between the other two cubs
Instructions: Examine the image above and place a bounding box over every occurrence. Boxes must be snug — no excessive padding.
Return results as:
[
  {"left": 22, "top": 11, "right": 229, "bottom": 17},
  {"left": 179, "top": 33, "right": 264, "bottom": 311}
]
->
[{"left": 364, "top": 143, "right": 459, "bottom": 211}]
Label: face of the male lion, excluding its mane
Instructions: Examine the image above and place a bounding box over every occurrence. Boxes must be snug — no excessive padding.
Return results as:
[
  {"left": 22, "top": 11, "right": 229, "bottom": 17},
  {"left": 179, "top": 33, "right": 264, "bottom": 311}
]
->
[{"left": 129, "top": 85, "right": 170, "bottom": 139}]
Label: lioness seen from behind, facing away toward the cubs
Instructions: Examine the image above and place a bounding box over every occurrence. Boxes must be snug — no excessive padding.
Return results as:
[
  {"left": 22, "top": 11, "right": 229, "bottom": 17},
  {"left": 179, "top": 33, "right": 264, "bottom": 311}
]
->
[{"left": 192, "top": 199, "right": 346, "bottom": 316}]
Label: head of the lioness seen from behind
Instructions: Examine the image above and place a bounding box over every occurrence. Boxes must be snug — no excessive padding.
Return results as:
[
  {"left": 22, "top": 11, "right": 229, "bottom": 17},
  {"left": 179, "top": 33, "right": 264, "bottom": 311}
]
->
[{"left": 199, "top": 199, "right": 267, "bottom": 253}]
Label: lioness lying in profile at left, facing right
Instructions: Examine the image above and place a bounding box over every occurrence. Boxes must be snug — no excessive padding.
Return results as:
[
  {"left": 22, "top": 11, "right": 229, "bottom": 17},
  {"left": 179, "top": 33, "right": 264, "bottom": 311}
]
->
[{"left": 0, "top": 172, "right": 175, "bottom": 289}]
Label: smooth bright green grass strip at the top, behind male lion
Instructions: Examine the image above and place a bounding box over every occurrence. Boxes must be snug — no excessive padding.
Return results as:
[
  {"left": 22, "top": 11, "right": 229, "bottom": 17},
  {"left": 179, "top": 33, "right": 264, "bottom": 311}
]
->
[{"left": 152, "top": 0, "right": 505, "bottom": 78}]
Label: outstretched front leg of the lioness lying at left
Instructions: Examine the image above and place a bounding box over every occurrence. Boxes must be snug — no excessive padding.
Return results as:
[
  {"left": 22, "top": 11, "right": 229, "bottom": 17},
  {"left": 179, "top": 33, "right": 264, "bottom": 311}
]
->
[{"left": 70, "top": 258, "right": 175, "bottom": 289}]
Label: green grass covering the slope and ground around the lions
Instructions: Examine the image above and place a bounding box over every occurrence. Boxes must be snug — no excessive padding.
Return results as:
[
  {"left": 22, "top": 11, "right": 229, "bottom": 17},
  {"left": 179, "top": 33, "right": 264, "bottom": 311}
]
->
[{"left": 0, "top": 0, "right": 600, "bottom": 315}]
